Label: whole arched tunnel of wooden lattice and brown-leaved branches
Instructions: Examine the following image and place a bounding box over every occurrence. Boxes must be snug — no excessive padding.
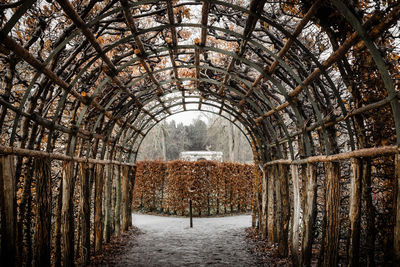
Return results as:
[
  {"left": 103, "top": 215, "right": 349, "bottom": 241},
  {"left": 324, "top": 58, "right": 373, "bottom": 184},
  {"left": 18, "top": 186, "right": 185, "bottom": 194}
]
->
[{"left": 0, "top": 0, "right": 400, "bottom": 266}]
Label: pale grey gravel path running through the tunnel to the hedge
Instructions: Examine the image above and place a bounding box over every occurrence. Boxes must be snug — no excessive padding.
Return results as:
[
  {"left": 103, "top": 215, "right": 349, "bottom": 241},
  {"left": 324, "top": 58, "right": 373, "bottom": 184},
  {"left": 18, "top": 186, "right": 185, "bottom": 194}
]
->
[{"left": 117, "top": 214, "right": 257, "bottom": 267}]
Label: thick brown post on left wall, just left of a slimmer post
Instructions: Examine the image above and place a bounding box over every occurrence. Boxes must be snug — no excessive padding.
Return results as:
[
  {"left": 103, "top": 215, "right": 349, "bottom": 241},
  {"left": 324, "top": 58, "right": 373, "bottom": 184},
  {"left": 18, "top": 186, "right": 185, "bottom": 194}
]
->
[{"left": 61, "top": 161, "right": 75, "bottom": 266}]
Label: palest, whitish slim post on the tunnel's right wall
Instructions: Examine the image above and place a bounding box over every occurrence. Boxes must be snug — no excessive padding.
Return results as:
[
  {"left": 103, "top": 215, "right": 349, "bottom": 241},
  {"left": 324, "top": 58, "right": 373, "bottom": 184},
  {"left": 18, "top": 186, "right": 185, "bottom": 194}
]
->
[{"left": 290, "top": 164, "right": 300, "bottom": 266}]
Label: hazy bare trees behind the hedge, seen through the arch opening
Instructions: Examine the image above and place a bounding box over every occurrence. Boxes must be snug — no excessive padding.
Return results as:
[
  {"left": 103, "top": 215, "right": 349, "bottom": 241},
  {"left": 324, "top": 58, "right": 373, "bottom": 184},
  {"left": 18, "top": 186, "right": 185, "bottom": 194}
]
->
[{"left": 138, "top": 117, "right": 253, "bottom": 162}]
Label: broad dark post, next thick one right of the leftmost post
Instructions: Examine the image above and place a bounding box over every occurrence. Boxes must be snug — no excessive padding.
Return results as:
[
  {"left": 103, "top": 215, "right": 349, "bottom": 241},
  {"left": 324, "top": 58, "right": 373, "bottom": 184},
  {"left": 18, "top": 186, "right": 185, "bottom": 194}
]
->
[{"left": 33, "top": 158, "right": 51, "bottom": 266}]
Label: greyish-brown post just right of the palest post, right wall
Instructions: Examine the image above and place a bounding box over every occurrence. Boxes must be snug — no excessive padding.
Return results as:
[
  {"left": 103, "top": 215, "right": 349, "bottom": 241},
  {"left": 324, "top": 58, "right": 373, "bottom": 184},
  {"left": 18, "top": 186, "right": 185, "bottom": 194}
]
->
[{"left": 301, "top": 163, "right": 317, "bottom": 266}]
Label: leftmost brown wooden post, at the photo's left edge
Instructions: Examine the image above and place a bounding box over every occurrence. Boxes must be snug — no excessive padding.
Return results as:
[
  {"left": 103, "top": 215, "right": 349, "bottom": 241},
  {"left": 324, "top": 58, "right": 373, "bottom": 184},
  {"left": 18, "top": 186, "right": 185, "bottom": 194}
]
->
[{"left": 0, "top": 155, "right": 17, "bottom": 266}]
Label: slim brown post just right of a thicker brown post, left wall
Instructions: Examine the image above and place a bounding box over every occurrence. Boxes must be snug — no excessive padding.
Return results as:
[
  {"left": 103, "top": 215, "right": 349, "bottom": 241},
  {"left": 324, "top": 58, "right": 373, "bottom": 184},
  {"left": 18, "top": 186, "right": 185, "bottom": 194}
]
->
[{"left": 79, "top": 163, "right": 90, "bottom": 266}]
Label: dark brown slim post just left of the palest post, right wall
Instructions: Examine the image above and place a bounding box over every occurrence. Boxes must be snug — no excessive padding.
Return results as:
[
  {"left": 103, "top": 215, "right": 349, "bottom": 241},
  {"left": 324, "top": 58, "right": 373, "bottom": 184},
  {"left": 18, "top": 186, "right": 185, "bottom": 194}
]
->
[{"left": 278, "top": 164, "right": 290, "bottom": 257}]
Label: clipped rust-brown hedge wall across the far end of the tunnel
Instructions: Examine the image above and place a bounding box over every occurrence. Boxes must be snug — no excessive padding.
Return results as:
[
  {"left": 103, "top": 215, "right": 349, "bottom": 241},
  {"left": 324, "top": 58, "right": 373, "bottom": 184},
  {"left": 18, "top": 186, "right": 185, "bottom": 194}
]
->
[{"left": 133, "top": 161, "right": 254, "bottom": 216}]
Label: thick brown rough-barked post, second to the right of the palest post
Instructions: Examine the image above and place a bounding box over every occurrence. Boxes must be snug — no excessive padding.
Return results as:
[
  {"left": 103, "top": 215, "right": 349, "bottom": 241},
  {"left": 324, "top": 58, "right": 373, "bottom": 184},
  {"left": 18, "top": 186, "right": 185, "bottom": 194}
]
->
[{"left": 323, "top": 162, "right": 340, "bottom": 266}]
